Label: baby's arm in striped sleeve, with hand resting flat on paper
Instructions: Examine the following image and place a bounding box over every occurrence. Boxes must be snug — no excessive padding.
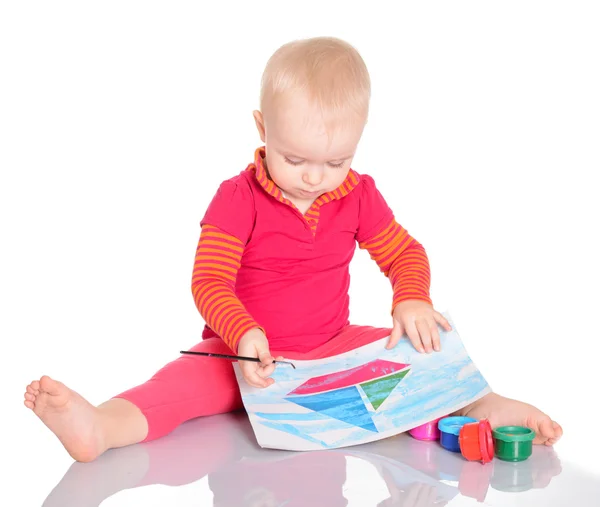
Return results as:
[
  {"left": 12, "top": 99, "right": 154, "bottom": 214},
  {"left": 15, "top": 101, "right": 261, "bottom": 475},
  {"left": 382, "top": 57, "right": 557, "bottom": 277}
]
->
[{"left": 359, "top": 218, "right": 451, "bottom": 352}]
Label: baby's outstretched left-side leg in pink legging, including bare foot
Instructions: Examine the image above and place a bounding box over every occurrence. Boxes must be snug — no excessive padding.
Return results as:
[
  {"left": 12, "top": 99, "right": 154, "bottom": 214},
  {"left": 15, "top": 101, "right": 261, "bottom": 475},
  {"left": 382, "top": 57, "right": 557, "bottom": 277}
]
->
[{"left": 25, "top": 338, "right": 242, "bottom": 462}]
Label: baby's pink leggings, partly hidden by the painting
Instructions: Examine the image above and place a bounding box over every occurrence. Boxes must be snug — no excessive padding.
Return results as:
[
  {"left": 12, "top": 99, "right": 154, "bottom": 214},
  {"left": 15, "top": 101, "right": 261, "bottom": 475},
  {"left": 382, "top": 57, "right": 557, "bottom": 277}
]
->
[{"left": 115, "top": 326, "right": 390, "bottom": 442}]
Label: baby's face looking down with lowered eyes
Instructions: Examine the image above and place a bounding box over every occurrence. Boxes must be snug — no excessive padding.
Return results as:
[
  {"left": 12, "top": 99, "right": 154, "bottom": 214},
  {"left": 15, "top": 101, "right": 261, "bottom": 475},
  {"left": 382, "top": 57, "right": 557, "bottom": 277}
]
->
[{"left": 255, "top": 97, "right": 365, "bottom": 202}]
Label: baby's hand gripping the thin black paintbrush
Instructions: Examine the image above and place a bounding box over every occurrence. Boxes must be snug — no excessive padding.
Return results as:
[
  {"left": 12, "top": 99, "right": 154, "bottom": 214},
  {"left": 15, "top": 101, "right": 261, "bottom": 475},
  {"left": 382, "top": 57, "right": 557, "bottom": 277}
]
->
[{"left": 238, "top": 328, "right": 283, "bottom": 387}]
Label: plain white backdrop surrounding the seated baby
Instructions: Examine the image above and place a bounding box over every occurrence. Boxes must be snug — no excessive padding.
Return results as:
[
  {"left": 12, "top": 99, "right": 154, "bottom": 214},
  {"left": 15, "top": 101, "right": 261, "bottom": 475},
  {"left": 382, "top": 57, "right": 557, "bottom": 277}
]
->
[{"left": 0, "top": 1, "right": 600, "bottom": 505}]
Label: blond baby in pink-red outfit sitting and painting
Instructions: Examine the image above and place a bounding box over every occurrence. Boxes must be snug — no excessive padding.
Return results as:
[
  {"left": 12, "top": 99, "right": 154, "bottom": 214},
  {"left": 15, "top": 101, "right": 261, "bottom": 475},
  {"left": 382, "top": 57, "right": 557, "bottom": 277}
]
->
[{"left": 25, "top": 37, "right": 562, "bottom": 462}]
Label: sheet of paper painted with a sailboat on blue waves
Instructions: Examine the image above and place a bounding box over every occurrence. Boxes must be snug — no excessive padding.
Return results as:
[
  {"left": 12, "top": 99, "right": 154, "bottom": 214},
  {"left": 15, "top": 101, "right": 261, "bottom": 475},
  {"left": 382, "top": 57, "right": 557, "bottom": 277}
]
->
[{"left": 234, "top": 314, "right": 491, "bottom": 451}]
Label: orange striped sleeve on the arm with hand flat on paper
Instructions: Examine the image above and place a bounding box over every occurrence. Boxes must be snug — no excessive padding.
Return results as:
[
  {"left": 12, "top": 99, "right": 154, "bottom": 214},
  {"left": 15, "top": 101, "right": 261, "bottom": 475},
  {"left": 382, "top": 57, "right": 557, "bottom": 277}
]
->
[{"left": 359, "top": 219, "right": 431, "bottom": 311}]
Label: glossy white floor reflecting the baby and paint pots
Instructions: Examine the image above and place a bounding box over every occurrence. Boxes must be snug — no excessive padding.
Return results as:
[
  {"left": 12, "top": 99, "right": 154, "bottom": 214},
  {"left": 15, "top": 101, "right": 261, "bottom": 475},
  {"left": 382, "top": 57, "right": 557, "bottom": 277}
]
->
[{"left": 18, "top": 412, "right": 600, "bottom": 507}]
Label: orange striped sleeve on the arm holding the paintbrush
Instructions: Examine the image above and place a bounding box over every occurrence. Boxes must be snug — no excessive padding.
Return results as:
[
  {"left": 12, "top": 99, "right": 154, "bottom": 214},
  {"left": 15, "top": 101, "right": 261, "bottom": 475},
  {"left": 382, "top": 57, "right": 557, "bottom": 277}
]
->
[{"left": 192, "top": 225, "right": 264, "bottom": 352}]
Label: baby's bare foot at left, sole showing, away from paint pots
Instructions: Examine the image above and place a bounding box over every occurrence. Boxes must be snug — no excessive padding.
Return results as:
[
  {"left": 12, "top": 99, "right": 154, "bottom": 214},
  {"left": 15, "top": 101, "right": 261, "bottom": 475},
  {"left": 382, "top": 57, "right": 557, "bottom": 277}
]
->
[{"left": 25, "top": 376, "right": 105, "bottom": 462}]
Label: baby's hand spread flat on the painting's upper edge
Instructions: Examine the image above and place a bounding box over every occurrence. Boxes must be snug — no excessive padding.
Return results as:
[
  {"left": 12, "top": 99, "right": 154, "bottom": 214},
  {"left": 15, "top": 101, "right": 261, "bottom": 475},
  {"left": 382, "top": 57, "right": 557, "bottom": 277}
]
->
[{"left": 386, "top": 299, "right": 452, "bottom": 353}]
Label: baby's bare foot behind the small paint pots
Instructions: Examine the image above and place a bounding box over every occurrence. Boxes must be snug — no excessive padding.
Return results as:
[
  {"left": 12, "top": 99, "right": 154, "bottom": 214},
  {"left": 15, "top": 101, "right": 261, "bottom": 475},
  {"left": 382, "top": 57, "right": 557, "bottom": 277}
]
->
[{"left": 458, "top": 393, "right": 563, "bottom": 445}]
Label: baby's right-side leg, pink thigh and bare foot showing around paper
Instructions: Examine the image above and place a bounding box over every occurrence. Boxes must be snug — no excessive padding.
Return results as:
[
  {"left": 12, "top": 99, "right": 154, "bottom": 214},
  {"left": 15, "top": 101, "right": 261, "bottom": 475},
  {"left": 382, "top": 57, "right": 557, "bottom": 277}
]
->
[{"left": 290, "top": 326, "right": 563, "bottom": 445}]
